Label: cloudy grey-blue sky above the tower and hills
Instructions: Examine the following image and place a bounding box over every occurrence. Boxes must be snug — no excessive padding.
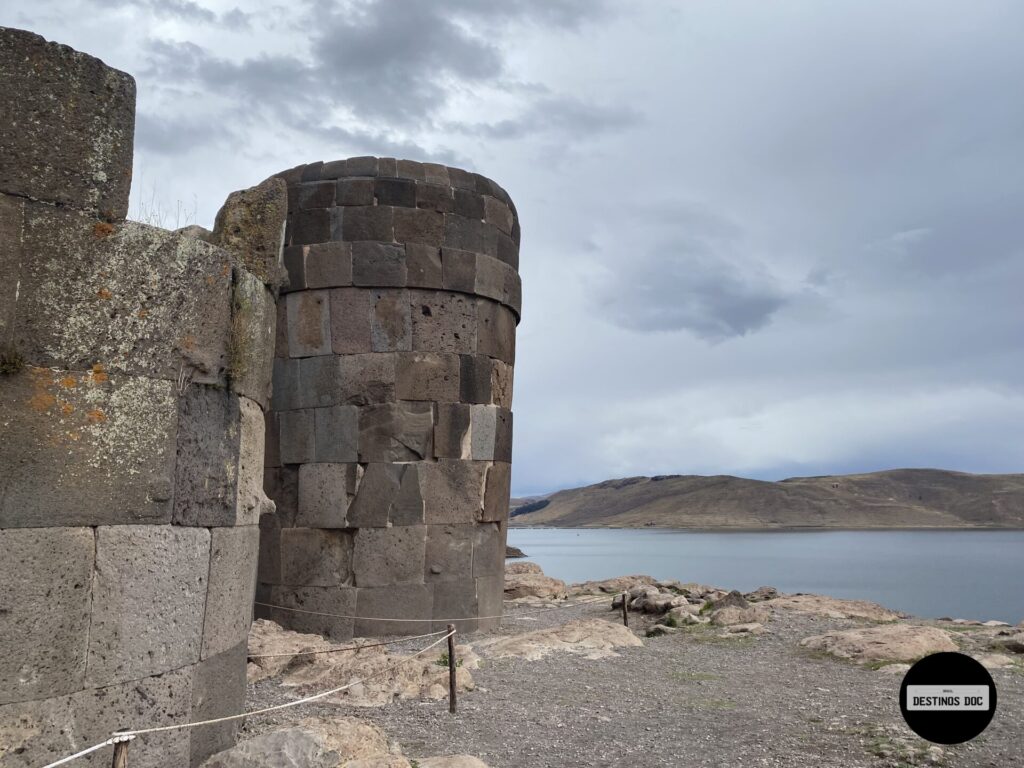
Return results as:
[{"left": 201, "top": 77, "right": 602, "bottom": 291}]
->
[{"left": 0, "top": 0, "right": 1024, "bottom": 495}]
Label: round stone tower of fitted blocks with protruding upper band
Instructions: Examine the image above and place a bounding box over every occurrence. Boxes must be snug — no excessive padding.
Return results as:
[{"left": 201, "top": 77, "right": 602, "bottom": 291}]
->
[{"left": 257, "top": 158, "right": 521, "bottom": 639}]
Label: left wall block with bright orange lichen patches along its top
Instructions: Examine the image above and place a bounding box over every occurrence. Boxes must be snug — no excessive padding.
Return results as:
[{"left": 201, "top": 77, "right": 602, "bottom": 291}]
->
[{"left": 0, "top": 365, "right": 178, "bottom": 528}]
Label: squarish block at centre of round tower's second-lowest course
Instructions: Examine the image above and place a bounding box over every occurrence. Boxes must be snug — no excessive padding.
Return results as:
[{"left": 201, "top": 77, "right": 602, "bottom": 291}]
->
[{"left": 353, "top": 528, "right": 427, "bottom": 587}]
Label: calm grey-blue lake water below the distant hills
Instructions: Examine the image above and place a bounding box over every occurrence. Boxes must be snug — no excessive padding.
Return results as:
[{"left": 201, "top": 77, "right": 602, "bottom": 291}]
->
[{"left": 509, "top": 528, "right": 1024, "bottom": 624}]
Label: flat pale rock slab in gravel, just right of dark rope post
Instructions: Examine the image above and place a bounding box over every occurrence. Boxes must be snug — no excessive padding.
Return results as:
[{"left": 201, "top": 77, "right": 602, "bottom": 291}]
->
[{"left": 473, "top": 618, "right": 643, "bottom": 662}]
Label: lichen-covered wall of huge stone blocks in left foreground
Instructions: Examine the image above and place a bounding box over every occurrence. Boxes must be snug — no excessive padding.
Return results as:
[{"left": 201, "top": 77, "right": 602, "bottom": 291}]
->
[{"left": 0, "top": 29, "right": 285, "bottom": 768}]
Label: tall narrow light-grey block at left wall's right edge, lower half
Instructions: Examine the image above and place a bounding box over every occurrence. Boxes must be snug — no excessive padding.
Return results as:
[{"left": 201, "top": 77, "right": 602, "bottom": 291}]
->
[{"left": 201, "top": 525, "right": 259, "bottom": 663}]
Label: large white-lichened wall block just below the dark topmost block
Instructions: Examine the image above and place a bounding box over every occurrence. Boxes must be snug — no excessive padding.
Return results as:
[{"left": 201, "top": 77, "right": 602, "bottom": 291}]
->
[{"left": 12, "top": 203, "right": 234, "bottom": 385}]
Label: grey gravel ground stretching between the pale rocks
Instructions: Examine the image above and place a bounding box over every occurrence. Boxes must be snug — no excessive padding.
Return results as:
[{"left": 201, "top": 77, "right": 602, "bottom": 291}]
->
[{"left": 245, "top": 605, "right": 1024, "bottom": 768}]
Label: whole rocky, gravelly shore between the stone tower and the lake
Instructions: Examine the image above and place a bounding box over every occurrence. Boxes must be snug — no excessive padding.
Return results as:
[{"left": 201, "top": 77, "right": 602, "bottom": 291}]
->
[{"left": 206, "top": 562, "right": 1024, "bottom": 768}]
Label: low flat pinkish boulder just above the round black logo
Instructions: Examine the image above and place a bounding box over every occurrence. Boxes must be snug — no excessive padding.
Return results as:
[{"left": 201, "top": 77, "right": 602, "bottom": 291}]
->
[{"left": 800, "top": 624, "right": 957, "bottom": 664}]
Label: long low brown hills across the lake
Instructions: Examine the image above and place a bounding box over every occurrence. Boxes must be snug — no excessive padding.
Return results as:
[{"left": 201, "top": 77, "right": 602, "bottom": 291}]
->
[{"left": 511, "top": 469, "right": 1024, "bottom": 528}]
